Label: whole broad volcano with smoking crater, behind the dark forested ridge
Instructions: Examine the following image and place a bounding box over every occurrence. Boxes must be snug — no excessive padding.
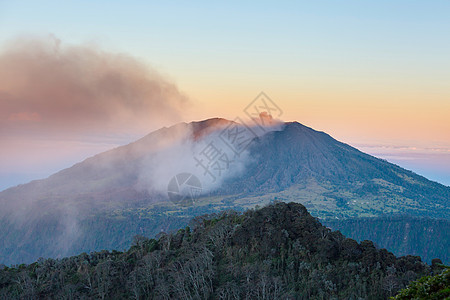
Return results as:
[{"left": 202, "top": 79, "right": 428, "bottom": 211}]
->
[{"left": 0, "top": 118, "right": 450, "bottom": 263}]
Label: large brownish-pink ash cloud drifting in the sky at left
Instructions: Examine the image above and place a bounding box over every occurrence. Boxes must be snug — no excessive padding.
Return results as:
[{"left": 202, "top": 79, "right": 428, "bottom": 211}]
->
[{"left": 0, "top": 37, "right": 188, "bottom": 135}]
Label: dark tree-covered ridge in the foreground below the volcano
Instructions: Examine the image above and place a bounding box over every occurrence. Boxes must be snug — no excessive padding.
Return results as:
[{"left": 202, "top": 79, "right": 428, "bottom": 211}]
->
[{"left": 0, "top": 203, "right": 433, "bottom": 299}]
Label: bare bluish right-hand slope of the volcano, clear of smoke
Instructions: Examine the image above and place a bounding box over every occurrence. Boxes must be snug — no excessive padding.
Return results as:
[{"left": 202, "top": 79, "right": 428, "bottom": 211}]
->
[{"left": 222, "top": 123, "right": 450, "bottom": 219}]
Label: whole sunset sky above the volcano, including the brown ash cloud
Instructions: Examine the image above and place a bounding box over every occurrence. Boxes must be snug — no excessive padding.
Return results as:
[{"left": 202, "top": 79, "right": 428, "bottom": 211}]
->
[{"left": 0, "top": 0, "right": 450, "bottom": 190}]
